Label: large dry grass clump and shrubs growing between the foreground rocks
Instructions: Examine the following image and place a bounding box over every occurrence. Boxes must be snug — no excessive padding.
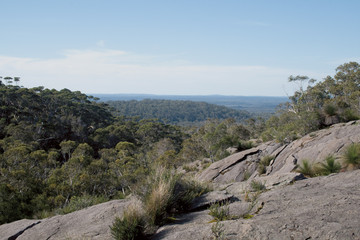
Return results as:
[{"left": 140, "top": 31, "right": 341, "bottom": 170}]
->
[{"left": 111, "top": 167, "right": 208, "bottom": 240}]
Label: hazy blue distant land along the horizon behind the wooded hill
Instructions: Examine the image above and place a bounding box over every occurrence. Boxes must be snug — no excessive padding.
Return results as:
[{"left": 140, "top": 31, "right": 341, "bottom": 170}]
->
[{"left": 92, "top": 94, "right": 288, "bottom": 114}]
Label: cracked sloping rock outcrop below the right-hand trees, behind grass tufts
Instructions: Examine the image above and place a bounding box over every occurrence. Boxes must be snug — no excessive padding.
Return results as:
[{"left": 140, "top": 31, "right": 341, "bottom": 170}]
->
[{"left": 198, "top": 121, "right": 360, "bottom": 187}]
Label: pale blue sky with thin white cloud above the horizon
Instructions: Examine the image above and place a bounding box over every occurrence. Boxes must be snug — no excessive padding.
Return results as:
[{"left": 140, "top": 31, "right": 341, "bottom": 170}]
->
[{"left": 0, "top": 0, "right": 360, "bottom": 96}]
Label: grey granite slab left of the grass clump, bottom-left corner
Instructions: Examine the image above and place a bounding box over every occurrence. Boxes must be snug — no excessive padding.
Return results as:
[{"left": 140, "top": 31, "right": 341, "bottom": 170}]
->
[{"left": 0, "top": 200, "right": 130, "bottom": 240}]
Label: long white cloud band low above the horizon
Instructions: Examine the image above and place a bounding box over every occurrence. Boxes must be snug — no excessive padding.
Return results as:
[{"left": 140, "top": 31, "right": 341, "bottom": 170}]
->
[{"left": 0, "top": 49, "right": 313, "bottom": 96}]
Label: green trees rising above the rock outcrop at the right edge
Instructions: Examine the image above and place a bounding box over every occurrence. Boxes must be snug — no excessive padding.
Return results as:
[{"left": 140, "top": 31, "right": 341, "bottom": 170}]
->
[{"left": 261, "top": 62, "right": 360, "bottom": 143}]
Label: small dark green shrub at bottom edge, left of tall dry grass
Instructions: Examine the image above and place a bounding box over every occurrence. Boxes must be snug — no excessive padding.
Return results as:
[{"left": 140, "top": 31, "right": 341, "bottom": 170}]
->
[{"left": 110, "top": 204, "right": 146, "bottom": 240}]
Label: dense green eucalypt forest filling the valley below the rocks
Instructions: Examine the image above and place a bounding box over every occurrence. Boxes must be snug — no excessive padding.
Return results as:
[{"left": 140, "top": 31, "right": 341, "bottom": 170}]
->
[{"left": 0, "top": 62, "right": 360, "bottom": 224}]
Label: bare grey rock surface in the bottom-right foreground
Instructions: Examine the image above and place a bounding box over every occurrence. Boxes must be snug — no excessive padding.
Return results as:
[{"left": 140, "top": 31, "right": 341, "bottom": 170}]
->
[{"left": 153, "top": 170, "right": 360, "bottom": 240}]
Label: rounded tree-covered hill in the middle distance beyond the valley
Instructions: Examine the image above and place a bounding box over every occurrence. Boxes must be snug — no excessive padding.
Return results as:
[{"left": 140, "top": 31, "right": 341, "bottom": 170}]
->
[{"left": 107, "top": 99, "right": 250, "bottom": 125}]
